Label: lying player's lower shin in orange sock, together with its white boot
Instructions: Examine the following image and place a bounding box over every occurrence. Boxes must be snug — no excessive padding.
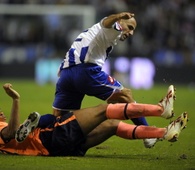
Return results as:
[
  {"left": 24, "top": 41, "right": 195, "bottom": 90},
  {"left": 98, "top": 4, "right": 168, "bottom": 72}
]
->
[{"left": 117, "top": 112, "right": 188, "bottom": 142}]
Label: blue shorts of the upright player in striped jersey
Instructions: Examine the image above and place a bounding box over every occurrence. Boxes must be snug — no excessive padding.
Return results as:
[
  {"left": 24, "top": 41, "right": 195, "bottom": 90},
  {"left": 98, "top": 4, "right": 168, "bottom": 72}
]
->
[{"left": 53, "top": 63, "right": 122, "bottom": 110}]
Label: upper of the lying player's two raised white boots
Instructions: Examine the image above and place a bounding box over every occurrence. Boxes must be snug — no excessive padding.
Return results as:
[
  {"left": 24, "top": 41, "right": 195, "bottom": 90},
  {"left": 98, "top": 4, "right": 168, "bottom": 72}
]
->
[{"left": 159, "top": 85, "right": 176, "bottom": 119}]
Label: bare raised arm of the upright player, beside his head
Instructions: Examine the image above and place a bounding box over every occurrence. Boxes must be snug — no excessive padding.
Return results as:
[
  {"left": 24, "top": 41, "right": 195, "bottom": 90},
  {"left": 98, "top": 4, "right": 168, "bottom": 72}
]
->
[{"left": 102, "top": 12, "right": 134, "bottom": 28}]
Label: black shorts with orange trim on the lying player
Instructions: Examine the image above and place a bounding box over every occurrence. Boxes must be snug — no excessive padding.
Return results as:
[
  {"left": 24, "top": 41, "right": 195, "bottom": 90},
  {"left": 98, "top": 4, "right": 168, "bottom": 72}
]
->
[{"left": 40, "top": 112, "right": 86, "bottom": 156}]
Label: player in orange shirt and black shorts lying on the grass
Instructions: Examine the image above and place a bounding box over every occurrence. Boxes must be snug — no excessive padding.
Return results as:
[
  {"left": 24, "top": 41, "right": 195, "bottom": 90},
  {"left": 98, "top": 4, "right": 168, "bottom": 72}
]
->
[{"left": 0, "top": 85, "right": 188, "bottom": 156}]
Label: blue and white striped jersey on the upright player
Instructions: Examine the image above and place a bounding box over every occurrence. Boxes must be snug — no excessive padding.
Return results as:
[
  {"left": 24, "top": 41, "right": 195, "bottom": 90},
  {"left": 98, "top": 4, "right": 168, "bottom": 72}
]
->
[{"left": 60, "top": 20, "right": 121, "bottom": 69}]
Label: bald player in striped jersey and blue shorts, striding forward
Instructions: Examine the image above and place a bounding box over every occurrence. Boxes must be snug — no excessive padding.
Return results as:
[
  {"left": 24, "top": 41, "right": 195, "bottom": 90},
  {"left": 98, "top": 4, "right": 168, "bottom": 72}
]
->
[{"left": 53, "top": 12, "right": 157, "bottom": 148}]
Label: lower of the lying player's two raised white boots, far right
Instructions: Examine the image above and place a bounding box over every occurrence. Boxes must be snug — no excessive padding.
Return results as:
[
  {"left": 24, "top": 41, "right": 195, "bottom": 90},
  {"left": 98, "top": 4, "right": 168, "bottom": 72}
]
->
[{"left": 164, "top": 112, "right": 188, "bottom": 142}]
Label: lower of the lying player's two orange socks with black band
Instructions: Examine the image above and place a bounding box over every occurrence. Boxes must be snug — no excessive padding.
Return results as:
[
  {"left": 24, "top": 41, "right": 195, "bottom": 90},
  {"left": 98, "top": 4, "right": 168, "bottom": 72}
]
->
[{"left": 116, "top": 121, "right": 166, "bottom": 139}]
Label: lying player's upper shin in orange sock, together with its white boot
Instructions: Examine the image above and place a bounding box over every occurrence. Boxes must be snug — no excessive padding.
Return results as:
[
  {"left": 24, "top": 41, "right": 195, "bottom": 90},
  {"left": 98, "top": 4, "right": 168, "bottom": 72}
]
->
[{"left": 106, "top": 85, "right": 176, "bottom": 119}]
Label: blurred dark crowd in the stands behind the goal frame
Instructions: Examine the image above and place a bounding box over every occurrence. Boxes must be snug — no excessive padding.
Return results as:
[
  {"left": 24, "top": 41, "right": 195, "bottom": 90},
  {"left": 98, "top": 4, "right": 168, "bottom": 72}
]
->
[{"left": 0, "top": 0, "right": 195, "bottom": 67}]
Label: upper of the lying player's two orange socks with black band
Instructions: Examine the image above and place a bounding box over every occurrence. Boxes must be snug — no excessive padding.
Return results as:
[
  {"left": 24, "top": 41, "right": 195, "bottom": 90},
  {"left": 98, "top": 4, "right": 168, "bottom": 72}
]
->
[{"left": 106, "top": 103, "right": 163, "bottom": 120}]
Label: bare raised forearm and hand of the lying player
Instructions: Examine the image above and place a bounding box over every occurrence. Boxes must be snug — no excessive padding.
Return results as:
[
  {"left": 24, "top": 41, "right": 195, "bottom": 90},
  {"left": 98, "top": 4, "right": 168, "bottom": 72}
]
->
[{"left": 1, "top": 83, "right": 20, "bottom": 140}]
